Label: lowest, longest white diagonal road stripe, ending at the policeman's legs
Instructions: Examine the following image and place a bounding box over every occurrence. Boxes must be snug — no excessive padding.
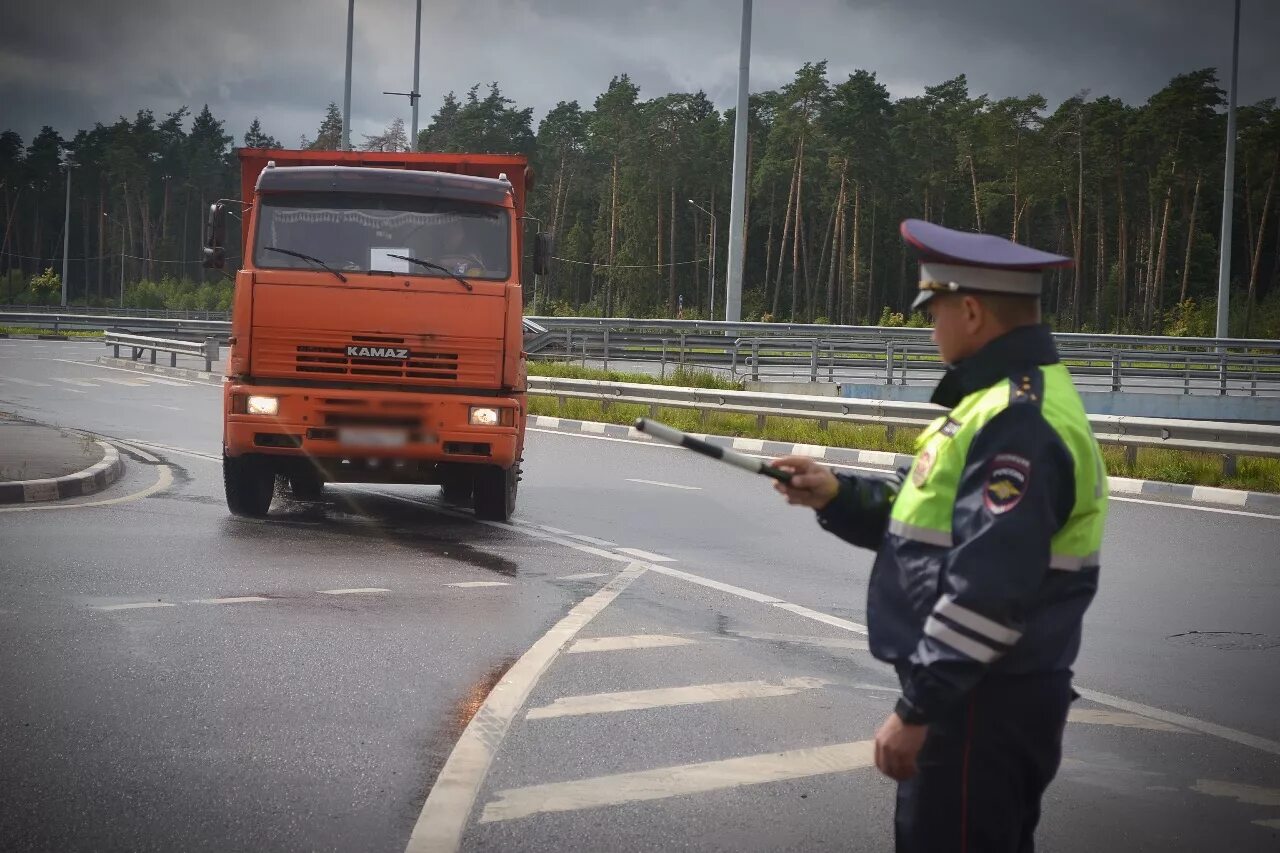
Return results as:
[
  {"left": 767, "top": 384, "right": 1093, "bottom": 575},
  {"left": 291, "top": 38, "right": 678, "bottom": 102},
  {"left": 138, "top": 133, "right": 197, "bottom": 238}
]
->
[{"left": 480, "top": 740, "right": 876, "bottom": 824}]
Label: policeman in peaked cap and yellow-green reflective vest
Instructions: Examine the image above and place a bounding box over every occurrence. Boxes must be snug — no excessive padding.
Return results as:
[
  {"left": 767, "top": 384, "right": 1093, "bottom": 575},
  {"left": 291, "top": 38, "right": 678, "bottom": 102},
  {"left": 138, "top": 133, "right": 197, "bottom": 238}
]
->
[{"left": 777, "top": 219, "right": 1107, "bottom": 853}]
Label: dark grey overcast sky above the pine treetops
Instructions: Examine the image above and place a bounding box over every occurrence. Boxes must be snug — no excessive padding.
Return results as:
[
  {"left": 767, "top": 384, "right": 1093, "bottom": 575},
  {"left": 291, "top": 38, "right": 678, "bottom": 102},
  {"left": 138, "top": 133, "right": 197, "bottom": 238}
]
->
[{"left": 0, "top": 0, "right": 1280, "bottom": 146}]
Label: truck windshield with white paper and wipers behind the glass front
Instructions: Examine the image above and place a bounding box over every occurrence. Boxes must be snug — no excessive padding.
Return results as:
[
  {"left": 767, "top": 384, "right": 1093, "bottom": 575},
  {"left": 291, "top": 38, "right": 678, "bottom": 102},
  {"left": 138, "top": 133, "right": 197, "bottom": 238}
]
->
[{"left": 253, "top": 192, "right": 511, "bottom": 280}]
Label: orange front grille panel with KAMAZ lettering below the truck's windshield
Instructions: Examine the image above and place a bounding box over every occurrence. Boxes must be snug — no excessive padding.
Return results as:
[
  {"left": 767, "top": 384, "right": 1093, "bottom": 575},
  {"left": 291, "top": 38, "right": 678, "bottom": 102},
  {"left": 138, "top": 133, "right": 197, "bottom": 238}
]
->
[{"left": 252, "top": 329, "right": 502, "bottom": 388}]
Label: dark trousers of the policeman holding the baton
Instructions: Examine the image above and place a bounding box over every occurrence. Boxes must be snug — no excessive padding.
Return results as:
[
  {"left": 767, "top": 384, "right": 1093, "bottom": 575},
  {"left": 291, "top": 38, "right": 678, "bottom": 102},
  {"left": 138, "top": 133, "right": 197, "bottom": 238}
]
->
[{"left": 895, "top": 672, "right": 1074, "bottom": 853}]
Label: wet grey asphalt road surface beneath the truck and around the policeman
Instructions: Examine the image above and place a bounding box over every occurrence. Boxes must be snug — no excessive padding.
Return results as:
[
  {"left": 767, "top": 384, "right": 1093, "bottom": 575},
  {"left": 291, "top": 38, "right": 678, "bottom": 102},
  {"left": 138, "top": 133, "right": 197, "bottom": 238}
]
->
[{"left": 0, "top": 341, "right": 1280, "bottom": 850}]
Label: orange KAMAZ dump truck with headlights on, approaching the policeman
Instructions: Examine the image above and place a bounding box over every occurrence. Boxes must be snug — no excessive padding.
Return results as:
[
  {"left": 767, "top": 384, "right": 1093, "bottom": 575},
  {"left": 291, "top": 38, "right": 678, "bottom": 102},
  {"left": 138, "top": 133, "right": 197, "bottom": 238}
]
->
[{"left": 205, "top": 149, "right": 549, "bottom": 520}]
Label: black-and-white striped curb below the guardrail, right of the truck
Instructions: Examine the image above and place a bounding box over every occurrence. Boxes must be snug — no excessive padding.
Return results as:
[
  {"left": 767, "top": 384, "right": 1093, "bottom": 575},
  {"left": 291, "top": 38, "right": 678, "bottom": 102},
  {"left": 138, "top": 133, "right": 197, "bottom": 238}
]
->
[{"left": 529, "top": 415, "right": 1280, "bottom": 512}]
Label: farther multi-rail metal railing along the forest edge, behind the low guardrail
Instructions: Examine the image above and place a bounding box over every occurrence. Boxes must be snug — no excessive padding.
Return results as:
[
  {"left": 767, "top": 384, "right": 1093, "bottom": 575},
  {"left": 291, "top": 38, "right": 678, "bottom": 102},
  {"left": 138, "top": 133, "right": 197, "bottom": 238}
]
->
[{"left": 12, "top": 310, "right": 1280, "bottom": 396}]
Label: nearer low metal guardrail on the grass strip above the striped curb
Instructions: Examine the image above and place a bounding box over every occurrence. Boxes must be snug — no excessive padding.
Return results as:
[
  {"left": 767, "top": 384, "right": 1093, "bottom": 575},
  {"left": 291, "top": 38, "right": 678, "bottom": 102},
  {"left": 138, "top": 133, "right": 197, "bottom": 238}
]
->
[{"left": 529, "top": 377, "right": 1280, "bottom": 466}]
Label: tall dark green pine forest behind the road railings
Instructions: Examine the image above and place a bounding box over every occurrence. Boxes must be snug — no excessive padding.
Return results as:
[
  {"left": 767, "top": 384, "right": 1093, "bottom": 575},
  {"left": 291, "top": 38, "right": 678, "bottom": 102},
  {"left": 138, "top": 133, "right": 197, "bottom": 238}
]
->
[{"left": 0, "top": 61, "right": 1280, "bottom": 337}]
